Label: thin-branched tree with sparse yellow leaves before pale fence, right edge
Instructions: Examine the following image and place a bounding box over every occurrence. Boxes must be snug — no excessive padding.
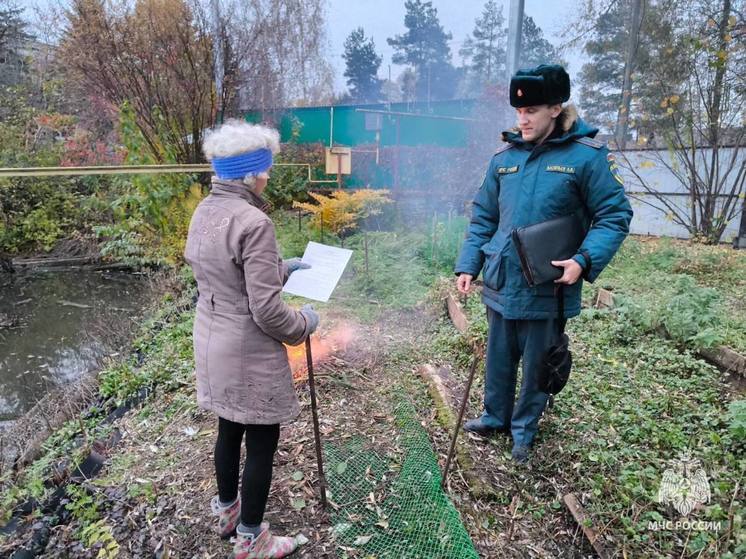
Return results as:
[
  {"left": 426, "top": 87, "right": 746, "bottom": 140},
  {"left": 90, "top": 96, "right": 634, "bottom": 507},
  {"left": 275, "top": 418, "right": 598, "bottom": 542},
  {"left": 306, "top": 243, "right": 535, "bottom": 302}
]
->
[{"left": 625, "top": 0, "right": 746, "bottom": 243}]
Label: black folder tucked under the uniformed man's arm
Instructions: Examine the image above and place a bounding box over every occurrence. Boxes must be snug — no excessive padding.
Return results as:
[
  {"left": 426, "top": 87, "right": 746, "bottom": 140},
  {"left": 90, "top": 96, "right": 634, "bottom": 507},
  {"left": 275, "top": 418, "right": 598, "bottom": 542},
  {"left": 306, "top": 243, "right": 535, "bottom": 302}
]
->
[{"left": 512, "top": 214, "right": 586, "bottom": 287}]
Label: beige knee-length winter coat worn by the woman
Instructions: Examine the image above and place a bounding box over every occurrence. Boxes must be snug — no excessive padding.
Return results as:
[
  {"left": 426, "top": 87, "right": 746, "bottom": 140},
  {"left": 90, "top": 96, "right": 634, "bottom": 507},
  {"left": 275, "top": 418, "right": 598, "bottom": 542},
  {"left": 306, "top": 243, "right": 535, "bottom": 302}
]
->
[{"left": 185, "top": 178, "right": 308, "bottom": 425}]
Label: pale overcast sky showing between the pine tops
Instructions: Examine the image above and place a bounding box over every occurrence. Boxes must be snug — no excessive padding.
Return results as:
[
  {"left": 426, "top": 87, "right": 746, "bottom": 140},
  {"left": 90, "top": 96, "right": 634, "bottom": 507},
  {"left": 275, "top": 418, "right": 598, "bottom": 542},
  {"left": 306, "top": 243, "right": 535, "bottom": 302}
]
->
[{"left": 327, "top": 0, "right": 582, "bottom": 91}]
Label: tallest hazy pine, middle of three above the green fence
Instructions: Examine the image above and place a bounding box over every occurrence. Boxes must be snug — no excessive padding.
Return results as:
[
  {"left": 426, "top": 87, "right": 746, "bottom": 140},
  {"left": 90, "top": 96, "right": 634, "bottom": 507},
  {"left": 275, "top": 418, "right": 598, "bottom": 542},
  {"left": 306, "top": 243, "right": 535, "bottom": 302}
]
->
[{"left": 387, "top": 0, "right": 458, "bottom": 99}]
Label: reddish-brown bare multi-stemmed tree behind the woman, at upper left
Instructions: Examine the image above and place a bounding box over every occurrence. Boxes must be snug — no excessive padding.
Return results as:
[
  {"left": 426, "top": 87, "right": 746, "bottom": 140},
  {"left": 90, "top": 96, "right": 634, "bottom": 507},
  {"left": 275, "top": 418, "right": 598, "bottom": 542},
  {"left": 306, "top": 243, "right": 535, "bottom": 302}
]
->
[{"left": 60, "top": 0, "right": 216, "bottom": 162}]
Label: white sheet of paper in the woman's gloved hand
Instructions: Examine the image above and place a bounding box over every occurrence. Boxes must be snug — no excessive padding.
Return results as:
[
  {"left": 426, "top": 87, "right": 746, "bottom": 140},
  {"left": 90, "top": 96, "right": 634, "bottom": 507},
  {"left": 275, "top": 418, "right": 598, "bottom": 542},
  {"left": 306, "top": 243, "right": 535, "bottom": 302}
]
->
[{"left": 282, "top": 241, "right": 352, "bottom": 303}]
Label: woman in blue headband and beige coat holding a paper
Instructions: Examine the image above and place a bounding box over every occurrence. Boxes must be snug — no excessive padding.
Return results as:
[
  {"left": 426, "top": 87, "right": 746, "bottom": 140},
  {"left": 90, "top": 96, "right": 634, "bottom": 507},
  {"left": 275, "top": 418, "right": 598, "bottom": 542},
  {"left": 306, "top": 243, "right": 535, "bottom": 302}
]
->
[{"left": 185, "top": 121, "right": 319, "bottom": 559}]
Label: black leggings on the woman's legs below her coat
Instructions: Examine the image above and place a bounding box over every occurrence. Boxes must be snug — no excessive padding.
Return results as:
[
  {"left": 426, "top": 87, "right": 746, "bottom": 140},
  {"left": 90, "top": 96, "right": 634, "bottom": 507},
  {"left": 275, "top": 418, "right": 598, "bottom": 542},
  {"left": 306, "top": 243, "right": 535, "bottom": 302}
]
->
[{"left": 215, "top": 417, "right": 280, "bottom": 526}]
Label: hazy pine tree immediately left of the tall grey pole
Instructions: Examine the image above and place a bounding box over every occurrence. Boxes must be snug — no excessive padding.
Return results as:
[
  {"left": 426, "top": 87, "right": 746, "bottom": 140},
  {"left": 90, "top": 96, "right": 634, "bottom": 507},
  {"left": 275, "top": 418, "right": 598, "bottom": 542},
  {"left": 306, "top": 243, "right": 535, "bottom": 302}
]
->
[{"left": 459, "top": 0, "right": 507, "bottom": 86}]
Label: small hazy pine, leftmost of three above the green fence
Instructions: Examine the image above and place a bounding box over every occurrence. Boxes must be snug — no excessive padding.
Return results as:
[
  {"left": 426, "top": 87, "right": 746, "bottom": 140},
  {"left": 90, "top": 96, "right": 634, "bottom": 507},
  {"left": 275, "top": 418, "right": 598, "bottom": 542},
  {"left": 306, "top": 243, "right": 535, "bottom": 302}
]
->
[{"left": 342, "top": 27, "right": 383, "bottom": 103}]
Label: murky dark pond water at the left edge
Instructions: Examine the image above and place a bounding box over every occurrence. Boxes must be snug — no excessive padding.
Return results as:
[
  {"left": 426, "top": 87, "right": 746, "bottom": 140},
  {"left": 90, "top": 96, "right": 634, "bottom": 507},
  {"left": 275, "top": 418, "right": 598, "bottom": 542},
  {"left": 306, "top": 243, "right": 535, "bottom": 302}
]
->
[{"left": 0, "top": 269, "right": 149, "bottom": 428}]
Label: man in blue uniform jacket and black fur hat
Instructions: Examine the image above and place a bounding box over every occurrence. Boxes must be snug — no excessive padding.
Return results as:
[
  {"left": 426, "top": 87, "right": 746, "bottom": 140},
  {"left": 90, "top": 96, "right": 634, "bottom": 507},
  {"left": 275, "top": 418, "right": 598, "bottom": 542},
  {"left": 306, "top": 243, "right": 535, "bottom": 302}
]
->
[{"left": 455, "top": 65, "right": 632, "bottom": 464}]
